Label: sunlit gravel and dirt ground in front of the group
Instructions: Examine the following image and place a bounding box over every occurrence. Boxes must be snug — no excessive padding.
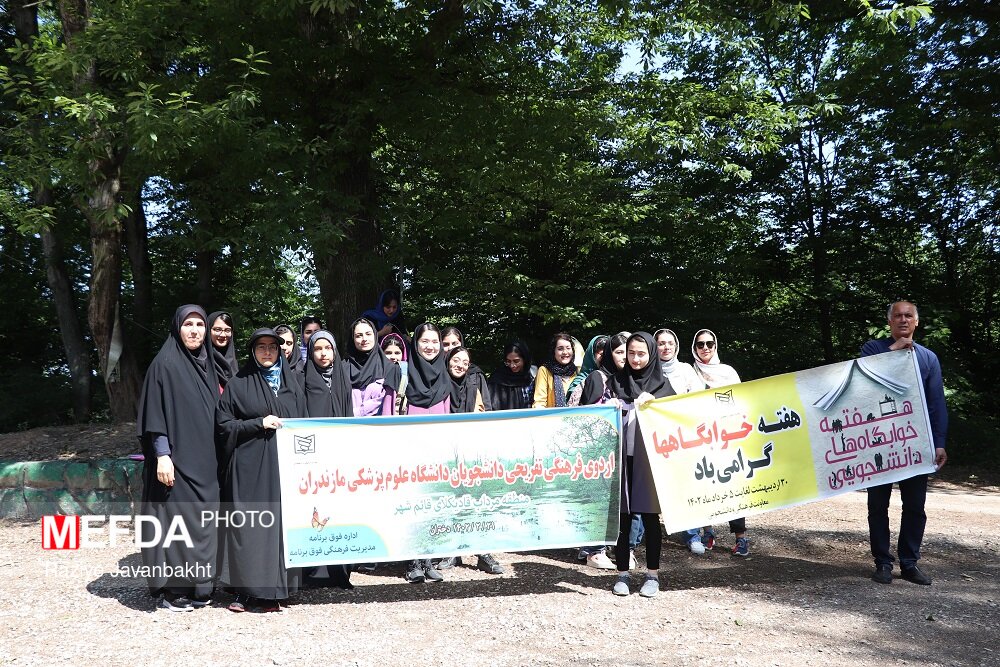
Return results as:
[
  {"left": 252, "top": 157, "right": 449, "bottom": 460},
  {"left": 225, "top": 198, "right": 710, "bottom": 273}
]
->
[{"left": 0, "top": 482, "right": 1000, "bottom": 667}]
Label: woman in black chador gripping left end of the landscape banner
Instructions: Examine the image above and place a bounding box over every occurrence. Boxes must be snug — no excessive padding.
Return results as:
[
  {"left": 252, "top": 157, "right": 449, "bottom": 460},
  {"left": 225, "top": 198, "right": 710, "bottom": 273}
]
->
[{"left": 215, "top": 329, "right": 306, "bottom": 612}]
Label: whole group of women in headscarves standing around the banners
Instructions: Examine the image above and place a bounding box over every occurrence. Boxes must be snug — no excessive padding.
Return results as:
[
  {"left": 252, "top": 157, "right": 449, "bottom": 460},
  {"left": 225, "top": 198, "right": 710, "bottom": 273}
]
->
[{"left": 137, "top": 291, "right": 748, "bottom": 612}]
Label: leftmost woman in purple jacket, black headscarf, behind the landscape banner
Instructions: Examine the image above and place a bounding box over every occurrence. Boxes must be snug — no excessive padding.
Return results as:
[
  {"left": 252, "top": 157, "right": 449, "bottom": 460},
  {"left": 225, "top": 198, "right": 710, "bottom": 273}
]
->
[{"left": 347, "top": 317, "right": 403, "bottom": 417}]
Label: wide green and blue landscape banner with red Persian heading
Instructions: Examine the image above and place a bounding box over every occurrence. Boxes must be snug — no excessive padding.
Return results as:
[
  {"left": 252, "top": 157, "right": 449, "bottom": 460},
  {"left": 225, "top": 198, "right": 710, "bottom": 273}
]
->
[{"left": 277, "top": 406, "right": 621, "bottom": 567}]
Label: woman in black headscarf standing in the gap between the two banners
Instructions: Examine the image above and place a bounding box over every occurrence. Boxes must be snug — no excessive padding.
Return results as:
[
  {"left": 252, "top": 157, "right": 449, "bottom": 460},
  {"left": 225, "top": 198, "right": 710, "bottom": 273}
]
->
[{"left": 611, "top": 331, "right": 674, "bottom": 597}]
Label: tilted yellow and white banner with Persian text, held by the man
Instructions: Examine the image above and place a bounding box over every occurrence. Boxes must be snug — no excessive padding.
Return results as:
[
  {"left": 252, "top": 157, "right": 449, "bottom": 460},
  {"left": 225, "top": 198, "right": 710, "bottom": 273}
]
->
[{"left": 637, "top": 350, "right": 935, "bottom": 532}]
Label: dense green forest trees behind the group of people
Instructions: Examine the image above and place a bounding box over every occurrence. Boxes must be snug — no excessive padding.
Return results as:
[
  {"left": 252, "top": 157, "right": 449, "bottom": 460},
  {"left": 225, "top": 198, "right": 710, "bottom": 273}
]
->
[{"left": 0, "top": 0, "right": 1000, "bottom": 466}]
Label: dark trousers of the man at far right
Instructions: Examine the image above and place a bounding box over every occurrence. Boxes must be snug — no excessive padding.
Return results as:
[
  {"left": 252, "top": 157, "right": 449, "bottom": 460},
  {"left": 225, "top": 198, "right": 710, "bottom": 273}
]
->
[{"left": 868, "top": 475, "right": 927, "bottom": 569}]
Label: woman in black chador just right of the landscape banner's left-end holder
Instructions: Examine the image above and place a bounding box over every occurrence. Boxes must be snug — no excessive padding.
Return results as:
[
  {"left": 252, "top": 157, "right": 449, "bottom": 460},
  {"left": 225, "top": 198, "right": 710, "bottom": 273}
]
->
[{"left": 304, "top": 329, "right": 354, "bottom": 589}]
